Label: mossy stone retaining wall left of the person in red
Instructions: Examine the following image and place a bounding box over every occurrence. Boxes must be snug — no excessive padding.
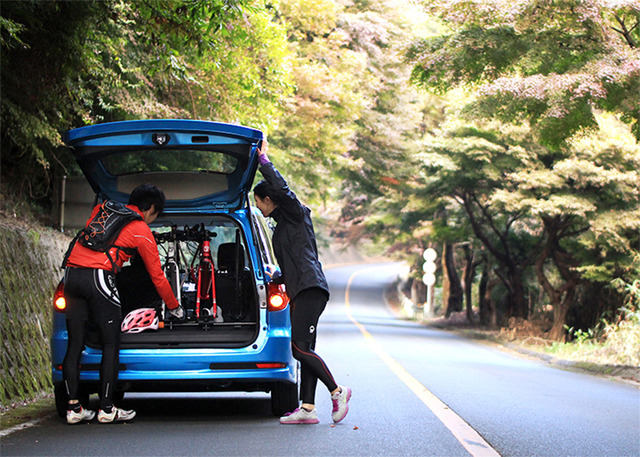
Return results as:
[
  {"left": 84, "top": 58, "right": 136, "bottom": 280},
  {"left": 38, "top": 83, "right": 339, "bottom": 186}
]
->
[{"left": 0, "top": 218, "right": 69, "bottom": 410}]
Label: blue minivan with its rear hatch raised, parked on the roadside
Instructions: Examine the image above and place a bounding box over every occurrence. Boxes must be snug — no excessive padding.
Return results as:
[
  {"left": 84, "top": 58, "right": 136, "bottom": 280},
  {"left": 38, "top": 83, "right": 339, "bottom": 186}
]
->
[{"left": 51, "top": 120, "right": 299, "bottom": 416}]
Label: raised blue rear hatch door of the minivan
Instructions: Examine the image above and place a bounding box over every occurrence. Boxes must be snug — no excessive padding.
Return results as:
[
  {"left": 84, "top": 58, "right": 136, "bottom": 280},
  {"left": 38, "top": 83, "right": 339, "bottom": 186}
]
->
[{"left": 63, "top": 119, "right": 263, "bottom": 213}]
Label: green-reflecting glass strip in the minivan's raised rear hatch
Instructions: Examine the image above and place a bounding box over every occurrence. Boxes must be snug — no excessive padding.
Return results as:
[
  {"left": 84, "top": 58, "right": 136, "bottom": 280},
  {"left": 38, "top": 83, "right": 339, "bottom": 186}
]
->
[{"left": 102, "top": 149, "right": 238, "bottom": 176}]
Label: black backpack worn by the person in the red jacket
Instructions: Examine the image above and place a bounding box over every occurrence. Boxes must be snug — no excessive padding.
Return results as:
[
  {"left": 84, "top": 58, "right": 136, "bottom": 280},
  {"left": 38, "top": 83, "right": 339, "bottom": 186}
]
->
[{"left": 60, "top": 200, "right": 143, "bottom": 273}]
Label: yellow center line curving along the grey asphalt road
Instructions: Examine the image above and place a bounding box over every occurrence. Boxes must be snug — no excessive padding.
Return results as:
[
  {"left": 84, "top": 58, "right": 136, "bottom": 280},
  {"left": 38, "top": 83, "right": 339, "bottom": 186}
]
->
[{"left": 344, "top": 267, "right": 500, "bottom": 457}]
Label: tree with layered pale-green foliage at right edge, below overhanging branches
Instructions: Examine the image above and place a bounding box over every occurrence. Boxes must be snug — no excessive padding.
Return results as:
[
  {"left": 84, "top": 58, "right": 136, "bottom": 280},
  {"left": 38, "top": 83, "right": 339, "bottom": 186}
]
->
[{"left": 494, "top": 114, "right": 640, "bottom": 339}]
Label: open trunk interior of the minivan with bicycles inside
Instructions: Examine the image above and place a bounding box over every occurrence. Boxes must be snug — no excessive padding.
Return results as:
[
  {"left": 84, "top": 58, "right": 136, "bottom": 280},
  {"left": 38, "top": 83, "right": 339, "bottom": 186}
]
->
[{"left": 96, "top": 215, "right": 260, "bottom": 349}]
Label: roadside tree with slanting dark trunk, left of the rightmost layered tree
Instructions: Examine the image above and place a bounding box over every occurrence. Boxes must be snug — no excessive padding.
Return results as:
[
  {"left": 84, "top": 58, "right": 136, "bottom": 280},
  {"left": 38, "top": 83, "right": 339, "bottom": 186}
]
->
[{"left": 421, "top": 120, "right": 536, "bottom": 318}]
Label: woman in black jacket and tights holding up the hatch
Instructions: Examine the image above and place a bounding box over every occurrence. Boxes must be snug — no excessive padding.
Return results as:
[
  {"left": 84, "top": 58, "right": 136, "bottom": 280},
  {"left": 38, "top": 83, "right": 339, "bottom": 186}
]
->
[{"left": 253, "top": 141, "right": 351, "bottom": 424}]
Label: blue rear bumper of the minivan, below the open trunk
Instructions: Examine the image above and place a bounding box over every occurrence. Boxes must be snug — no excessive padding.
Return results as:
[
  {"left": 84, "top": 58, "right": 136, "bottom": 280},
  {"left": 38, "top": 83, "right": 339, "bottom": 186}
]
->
[{"left": 51, "top": 312, "right": 297, "bottom": 391}]
